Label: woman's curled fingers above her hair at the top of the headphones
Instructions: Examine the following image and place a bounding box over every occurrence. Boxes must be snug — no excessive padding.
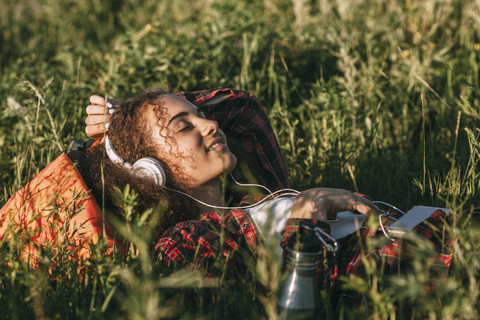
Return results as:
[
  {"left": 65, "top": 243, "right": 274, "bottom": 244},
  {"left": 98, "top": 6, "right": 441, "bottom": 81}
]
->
[{"left": 85, "top": 95, "right": 121, "bottom": 139}]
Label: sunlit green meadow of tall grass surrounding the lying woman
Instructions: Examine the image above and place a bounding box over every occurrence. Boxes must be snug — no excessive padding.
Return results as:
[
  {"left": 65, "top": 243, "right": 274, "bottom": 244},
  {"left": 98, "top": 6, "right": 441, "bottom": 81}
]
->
[{"left": 0, "top": 0, "right": 480, "bottom": 319}]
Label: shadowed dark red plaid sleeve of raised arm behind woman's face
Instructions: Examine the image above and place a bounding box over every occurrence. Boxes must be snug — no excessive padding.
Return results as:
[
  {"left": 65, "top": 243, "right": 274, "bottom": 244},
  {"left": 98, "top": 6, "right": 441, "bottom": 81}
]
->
[{"left": 178, "top": 89, "right": 290, "bottom": 189}]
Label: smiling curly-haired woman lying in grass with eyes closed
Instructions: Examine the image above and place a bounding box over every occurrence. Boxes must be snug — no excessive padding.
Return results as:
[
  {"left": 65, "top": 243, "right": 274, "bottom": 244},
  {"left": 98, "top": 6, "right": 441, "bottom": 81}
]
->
[{"left": 81, "top": 89, "right": 452, "bottom": 290}]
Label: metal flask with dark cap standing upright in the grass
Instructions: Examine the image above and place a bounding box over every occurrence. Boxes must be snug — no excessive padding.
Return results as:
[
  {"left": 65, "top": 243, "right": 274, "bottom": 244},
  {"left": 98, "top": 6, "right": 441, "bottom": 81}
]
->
[{"left": 278, "top": 227, "right": 322, "bottom": 320}]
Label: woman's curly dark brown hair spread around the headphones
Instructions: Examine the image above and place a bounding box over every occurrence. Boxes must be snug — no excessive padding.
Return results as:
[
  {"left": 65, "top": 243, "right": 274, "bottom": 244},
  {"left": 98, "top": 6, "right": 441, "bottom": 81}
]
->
[{"left": 81, "top": 90, "right": 199, "bottom": 237}]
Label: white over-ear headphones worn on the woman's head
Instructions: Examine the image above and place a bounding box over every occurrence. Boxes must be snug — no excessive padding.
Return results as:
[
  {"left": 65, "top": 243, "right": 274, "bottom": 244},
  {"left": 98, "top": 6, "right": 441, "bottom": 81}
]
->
[{"left": 105, "top": 136, "right": 167, "bottom": 187}]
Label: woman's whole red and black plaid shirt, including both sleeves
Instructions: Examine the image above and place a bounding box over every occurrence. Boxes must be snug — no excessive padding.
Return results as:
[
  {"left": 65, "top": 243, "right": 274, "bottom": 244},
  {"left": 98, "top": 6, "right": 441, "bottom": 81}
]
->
[{"left": 155, "top": 89, "right": 452, "bottom": 285}]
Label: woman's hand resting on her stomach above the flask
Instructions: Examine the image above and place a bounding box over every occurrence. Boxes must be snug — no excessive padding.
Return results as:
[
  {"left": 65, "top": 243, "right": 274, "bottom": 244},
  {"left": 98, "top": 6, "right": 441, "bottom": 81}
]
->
[{"left": 291, "top": 188, "right": 381, "bottom": 221}]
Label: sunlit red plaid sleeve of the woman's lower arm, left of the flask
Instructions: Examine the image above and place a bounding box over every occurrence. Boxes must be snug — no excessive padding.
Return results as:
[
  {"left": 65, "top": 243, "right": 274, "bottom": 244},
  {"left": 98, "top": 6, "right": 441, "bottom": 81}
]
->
[{"left": 155, "top": 210, "right": 257, "bottom": 277}]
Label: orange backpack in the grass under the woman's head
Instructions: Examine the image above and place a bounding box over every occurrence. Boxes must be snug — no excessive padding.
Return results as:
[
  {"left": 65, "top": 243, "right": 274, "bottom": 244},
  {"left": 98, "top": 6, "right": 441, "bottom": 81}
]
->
[{"left": 0, "top": 153, "right": 115, "bottom": 268}]
